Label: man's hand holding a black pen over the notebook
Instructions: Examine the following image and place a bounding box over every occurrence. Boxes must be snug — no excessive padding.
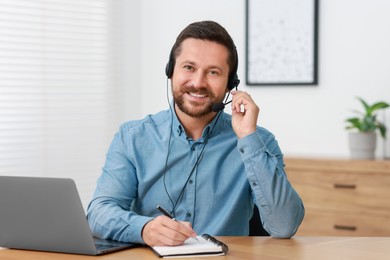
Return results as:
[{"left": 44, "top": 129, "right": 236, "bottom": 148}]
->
[{"left": 142, "top": 216, "right": 196, "bottom": 246}]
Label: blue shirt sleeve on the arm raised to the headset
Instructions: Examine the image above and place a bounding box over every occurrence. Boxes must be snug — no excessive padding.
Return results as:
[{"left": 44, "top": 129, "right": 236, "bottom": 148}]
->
[{"left": 237, "top": 130, "right": 304, "bottom": 238}]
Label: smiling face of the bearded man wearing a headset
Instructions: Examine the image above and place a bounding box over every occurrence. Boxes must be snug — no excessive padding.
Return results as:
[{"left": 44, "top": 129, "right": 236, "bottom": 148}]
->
[{"left": 171, "top": 38, "right": 229, "bottom": 118}]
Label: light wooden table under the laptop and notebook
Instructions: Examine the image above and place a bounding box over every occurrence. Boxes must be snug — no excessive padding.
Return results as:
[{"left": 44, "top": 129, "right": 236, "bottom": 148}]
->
[{"left": 0, "top": 236, "right": 390, "bottom": 260}]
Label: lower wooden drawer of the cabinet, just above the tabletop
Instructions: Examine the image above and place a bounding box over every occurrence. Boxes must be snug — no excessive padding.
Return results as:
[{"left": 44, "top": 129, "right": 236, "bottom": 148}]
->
[{"left": 296, "top": 208, "right": 390, "bottom": 236}]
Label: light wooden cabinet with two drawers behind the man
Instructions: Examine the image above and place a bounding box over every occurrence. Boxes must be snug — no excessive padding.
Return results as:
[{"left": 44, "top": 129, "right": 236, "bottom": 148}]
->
[{"left": 285, "top": 158, "right": 390, "bottom": 236}]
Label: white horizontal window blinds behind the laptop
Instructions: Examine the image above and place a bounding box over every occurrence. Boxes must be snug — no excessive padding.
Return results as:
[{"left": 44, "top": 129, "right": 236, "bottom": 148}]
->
[{"left": 0, "top": 0, "right": 122, "bottom": 206}]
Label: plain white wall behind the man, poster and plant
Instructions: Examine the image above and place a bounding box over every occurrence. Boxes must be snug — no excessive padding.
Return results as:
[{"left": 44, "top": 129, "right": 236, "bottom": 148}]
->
[{"left": 125, "top": 0, "right": 390, "bottom": 157}]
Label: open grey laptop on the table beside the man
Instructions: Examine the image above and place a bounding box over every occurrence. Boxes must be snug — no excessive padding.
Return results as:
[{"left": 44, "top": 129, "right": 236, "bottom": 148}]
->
[{"left": 0, "top": 176, "right": 137, "bottom": 255}]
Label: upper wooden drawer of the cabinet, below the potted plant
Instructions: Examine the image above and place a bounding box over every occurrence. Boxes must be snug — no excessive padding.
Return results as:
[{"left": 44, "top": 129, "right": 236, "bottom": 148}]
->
[{"left": 287, "top": 169, "right": 390, "bottom": 216}]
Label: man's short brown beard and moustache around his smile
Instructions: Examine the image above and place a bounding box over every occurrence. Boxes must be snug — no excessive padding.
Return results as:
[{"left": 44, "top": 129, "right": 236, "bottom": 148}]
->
[{"left": 172, "top": 87, "right": 223, "bottom": 118}]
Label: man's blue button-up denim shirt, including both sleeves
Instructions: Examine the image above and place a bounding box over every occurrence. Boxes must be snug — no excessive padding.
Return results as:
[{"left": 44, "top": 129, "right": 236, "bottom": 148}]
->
[{"left": 87, "top": 110, "right": 304, "bottom": 243}]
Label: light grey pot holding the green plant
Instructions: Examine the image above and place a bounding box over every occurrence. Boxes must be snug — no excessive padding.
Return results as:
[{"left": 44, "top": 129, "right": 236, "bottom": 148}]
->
[{"left": 348, "top": 132, "right": 376, "bottom": 160}]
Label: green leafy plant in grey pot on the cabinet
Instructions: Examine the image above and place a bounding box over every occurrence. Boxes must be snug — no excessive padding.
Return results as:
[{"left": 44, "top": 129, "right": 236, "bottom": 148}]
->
[{"left": 346, "top": 97, "right": 389, "bottom": 160}]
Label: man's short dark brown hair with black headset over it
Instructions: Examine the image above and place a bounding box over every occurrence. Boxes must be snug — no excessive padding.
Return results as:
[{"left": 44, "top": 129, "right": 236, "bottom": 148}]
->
[{"left": 166, "top": 21, "right": 238, "bottom": 88}]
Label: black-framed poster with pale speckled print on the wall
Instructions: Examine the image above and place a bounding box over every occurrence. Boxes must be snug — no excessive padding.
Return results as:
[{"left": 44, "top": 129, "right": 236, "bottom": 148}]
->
[{"left": 246, "top": 0, "right": 318, "bottom": 85}]
